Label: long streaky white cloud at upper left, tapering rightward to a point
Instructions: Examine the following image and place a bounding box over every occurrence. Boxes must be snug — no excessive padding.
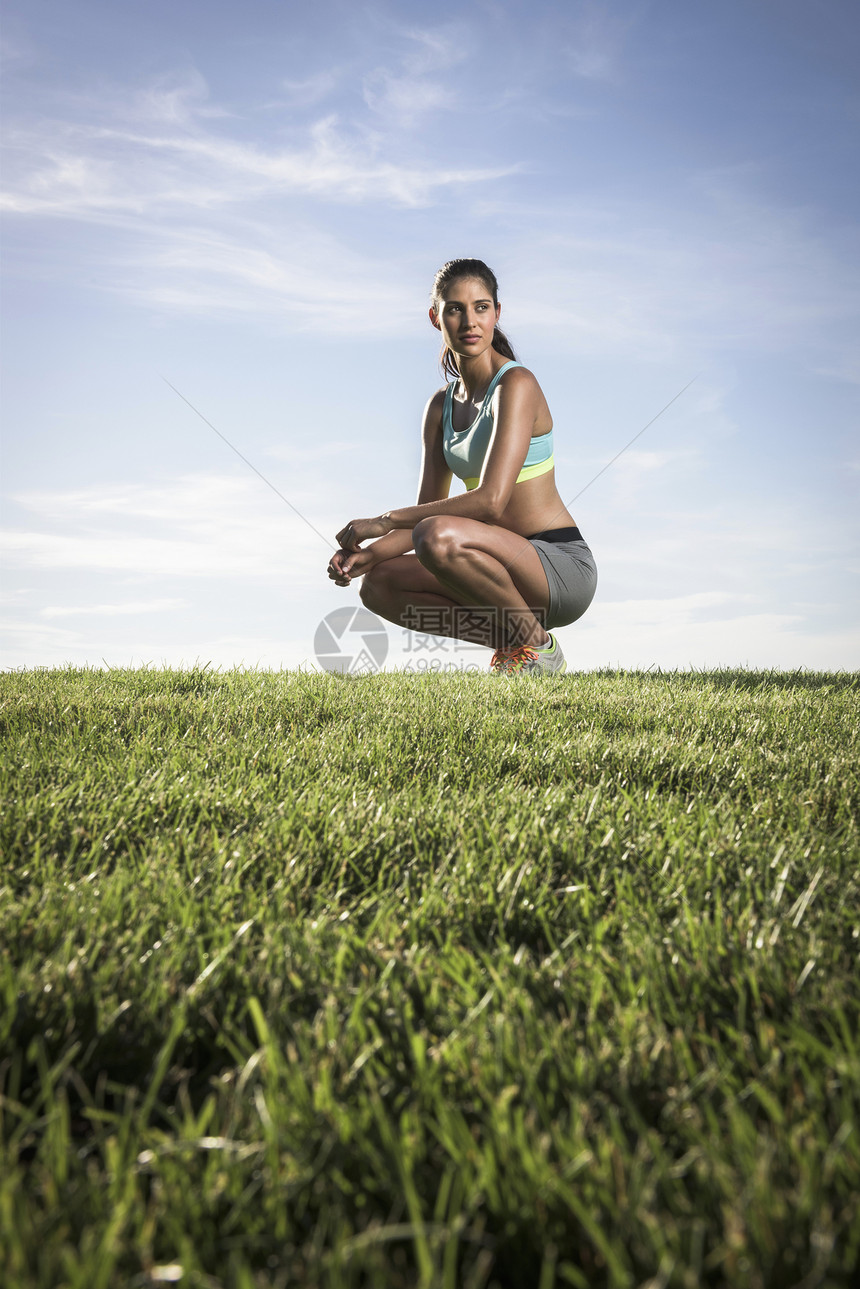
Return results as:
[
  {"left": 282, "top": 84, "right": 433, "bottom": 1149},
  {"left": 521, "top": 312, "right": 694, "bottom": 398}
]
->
[{"left": 3, "top": 76, "right": 516, "bottom": 219}]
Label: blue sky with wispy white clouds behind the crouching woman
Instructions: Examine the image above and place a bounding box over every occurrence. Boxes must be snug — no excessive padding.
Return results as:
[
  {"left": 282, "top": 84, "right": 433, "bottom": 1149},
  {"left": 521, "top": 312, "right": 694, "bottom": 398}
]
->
[{"left": 0, "top": 0, "right": 860, "bottom": 670}]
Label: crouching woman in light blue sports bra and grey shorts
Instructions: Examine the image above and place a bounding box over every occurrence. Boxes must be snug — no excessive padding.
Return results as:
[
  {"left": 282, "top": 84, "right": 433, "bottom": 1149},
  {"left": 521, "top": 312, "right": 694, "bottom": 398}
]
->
[{"left": 329, "top": 259, "right": 597, "bottom": 675}]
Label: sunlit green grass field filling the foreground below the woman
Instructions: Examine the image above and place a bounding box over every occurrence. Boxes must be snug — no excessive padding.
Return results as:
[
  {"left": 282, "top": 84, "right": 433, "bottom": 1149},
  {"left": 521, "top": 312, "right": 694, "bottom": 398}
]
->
[{"left": 0, "top": 669, "right": 860, "bottom": 1289}]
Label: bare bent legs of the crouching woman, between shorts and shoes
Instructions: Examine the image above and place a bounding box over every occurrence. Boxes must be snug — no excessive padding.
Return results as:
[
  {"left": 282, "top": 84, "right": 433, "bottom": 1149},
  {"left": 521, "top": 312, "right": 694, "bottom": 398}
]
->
[{"left": 361, "top": 514, "right": 549, "bottom": 648}]
